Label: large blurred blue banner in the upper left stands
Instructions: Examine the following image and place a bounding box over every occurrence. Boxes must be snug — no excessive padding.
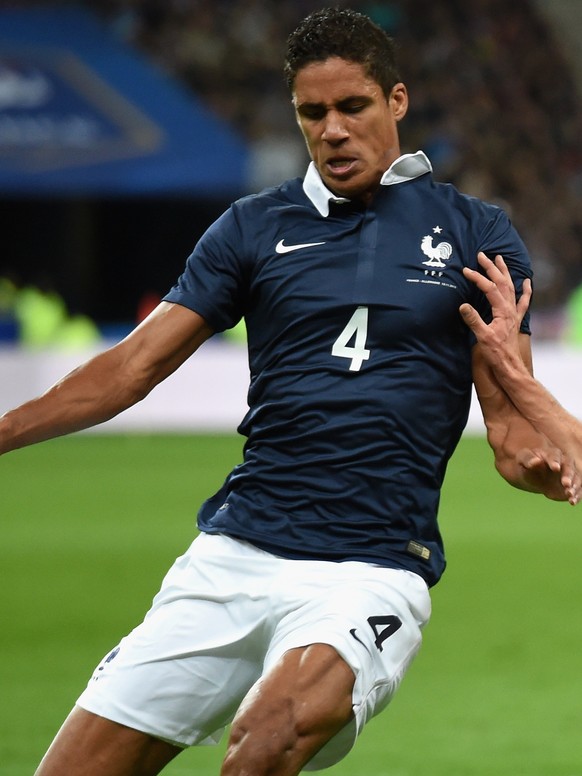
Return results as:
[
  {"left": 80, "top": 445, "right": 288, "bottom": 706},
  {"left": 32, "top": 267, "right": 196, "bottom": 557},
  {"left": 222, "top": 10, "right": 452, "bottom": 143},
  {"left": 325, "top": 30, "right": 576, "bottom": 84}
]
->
[{"left": 0, "top": 8, "right": 248, "bottom": 196}]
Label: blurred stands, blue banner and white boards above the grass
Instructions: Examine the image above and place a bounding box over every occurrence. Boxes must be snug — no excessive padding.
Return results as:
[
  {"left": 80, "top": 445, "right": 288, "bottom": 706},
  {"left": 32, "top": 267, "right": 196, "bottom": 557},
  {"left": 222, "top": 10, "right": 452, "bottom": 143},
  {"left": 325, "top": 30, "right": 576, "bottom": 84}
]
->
[{"left": 0, "top": 0, "right": 582, "bottom": 429}]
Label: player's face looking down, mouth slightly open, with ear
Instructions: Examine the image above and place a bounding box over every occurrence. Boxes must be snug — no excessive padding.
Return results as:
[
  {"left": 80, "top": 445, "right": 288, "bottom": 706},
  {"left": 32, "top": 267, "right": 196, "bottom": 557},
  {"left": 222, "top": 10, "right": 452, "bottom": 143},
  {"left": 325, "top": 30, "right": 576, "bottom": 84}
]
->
[{"left": 293, "top": 57, "right": 408, "bottom": 202}]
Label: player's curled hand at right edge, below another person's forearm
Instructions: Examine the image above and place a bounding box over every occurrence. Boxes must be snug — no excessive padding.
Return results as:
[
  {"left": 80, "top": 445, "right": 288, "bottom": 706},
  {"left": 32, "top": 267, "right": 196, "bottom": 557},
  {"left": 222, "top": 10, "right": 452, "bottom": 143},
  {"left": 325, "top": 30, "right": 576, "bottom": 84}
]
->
[{"left": 517, "top": 447, "right": 582, "bottom": 506}]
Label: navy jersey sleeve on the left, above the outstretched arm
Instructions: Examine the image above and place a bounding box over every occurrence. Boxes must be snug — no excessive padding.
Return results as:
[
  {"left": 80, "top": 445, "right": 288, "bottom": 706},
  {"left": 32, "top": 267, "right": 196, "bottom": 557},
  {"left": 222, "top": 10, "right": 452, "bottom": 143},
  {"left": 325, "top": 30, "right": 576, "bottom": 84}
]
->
[{"left": 164, "top": 206, "right": 248, "bottom": 332}]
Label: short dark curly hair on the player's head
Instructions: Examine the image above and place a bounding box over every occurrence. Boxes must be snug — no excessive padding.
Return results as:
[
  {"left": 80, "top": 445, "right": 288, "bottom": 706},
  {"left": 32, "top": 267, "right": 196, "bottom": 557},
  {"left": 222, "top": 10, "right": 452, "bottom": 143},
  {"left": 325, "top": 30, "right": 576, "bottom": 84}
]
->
[{"left": 283, "top": 8, "right": 401, "bottom": 95}]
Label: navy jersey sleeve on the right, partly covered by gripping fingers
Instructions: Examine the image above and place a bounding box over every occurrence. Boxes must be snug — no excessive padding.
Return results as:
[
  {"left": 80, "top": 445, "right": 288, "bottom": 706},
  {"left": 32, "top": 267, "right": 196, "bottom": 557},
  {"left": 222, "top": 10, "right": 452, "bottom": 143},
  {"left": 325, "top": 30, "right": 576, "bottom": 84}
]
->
[{"left": 477, "top": 207, "right": 533, "bottom": 334}]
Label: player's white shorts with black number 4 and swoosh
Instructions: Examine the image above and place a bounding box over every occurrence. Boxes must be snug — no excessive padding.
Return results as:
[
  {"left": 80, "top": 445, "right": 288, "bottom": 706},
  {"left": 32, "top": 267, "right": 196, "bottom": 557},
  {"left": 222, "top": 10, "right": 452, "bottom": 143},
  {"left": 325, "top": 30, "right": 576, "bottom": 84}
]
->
[{"left": 78, "top": 534, "right": 430, "bottom": 770}]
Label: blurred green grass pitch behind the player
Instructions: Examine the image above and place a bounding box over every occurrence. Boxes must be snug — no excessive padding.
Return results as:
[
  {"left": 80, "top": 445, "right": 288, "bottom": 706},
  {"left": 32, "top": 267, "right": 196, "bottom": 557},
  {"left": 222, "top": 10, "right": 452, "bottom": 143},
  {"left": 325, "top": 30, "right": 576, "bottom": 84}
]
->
[{"left": 0, "top": 435, "right": 582, "bottom": 776}]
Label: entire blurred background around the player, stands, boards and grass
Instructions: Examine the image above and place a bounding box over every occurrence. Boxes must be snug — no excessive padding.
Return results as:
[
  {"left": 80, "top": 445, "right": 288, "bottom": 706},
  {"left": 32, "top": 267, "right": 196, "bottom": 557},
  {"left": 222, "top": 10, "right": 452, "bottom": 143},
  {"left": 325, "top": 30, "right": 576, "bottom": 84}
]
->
[{"left": 0, "top": 0, "right": 582, "bottom": 776}]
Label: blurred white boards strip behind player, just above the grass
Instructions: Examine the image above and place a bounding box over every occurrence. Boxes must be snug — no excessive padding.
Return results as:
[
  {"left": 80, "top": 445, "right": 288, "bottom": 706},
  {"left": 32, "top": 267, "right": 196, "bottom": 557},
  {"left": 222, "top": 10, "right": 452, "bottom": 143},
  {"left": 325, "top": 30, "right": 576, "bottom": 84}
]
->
[{"left": 0, "top": 341, "right": 582, "bottom": 434}]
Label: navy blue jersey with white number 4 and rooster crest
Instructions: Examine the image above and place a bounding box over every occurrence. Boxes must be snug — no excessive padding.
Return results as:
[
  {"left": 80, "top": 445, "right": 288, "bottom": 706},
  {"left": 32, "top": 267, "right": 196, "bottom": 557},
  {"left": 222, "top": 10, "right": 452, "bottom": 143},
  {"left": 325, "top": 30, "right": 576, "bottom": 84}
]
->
[{"left": 165, "top": 155, "right": 531, "bottom": 585}]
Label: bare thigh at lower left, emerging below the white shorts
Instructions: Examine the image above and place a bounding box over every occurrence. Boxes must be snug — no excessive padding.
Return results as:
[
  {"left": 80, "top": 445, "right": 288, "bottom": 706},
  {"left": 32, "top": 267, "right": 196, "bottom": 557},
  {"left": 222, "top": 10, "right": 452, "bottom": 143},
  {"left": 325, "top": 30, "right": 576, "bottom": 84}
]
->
[{"left": 36, "top": 707, "right": 182, "bottom": 776}]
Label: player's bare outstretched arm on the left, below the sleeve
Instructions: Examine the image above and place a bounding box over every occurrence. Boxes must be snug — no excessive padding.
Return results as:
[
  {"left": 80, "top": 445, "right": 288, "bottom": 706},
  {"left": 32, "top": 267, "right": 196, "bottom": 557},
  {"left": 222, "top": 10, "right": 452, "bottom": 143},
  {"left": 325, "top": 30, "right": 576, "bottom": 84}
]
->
[{"left": 0, "top": 302, "right": 213, "bottom": 455}]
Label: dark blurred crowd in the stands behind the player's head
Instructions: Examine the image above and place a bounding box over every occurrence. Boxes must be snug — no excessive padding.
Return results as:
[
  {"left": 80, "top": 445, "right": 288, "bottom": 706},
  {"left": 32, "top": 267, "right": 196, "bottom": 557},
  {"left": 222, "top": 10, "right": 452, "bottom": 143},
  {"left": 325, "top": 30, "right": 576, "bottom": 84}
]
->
[{"left": 6, "top": 0, "right": 582, "bottom": 328}]
